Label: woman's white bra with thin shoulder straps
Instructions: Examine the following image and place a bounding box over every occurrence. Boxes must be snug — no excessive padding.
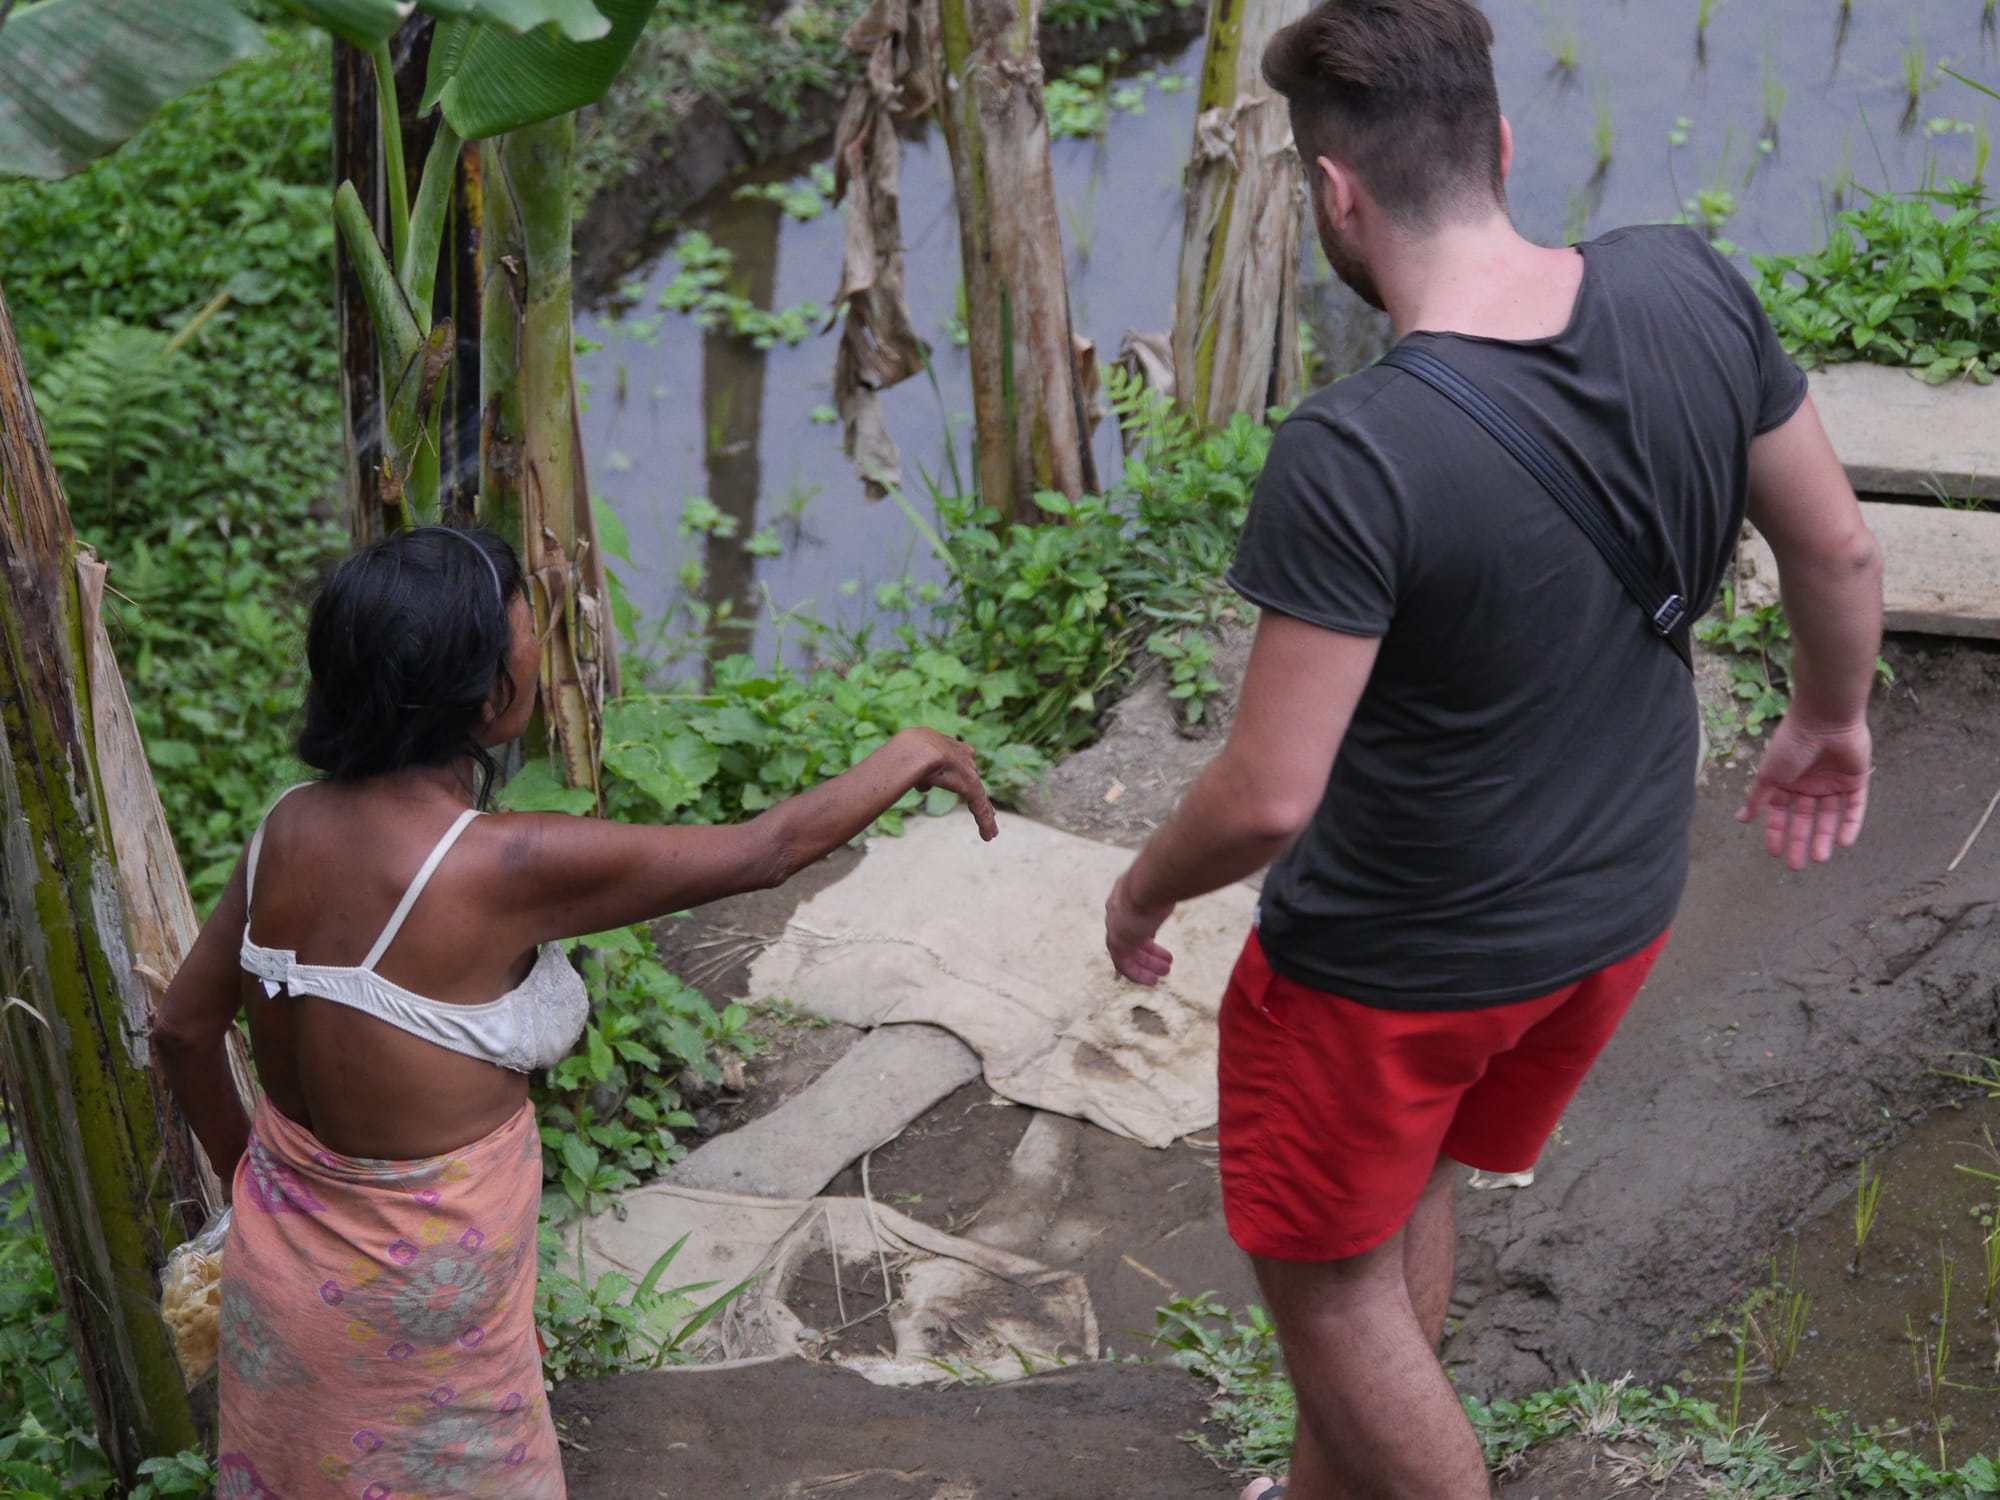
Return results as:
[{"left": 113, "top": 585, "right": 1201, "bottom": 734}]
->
[{"left": 242, "top": 786, "right": 590, "bottom": 1072}]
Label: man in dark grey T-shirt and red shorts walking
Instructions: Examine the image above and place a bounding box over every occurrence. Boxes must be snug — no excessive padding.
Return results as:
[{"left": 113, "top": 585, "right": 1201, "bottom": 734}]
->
[{"left": 1106, "top": 0, "right": 1882, "bottom": 1500}]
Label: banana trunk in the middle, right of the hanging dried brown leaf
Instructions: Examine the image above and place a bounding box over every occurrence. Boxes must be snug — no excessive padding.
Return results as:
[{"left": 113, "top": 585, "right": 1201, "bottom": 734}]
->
[{"left": 938, "top": 0, "right": 1098, "bottom": 522}]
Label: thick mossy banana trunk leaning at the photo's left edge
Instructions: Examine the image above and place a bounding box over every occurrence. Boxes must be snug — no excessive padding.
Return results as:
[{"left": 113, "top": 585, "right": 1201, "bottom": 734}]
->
[{"left": 0, "top": 280, "right": 214, "bottom": 1484}]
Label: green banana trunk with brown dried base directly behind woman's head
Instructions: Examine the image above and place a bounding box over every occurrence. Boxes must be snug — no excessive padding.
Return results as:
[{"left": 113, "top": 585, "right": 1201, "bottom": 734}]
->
[{"left": 480, "top": 114, "right": 618, "bottom": 802}]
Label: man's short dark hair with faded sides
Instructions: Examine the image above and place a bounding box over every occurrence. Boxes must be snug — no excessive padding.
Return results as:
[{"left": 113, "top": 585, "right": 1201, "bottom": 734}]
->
[{"left": 1264, "top": 0, "right": 1506, "bottom": 228}]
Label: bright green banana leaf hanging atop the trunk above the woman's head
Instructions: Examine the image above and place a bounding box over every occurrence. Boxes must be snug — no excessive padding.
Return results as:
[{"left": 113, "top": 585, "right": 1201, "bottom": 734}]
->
[{"left": 422, "top": 0, "right": 656, "bottom": 140}]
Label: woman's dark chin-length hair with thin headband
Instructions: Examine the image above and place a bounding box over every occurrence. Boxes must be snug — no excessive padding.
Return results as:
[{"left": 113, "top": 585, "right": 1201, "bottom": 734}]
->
[{"left": 298, "top": 526, "right": 532, "bottom": 804}]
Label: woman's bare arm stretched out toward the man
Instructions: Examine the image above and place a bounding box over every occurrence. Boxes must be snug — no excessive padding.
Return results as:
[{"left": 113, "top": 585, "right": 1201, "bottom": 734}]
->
[{"left": 492, "top": 730, "right": 1000, "bottom": 942}]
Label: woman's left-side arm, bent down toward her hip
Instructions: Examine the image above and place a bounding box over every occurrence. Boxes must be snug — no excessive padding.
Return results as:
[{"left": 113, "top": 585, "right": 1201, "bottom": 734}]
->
[{"left": 152, "top": 860, "right": 250, "bottom": 1196}]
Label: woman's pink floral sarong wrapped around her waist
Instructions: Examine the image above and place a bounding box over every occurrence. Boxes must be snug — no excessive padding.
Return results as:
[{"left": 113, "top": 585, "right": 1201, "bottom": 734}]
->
[{"left": 216, "top": 1100, "right": 564, "bottom": 1500}]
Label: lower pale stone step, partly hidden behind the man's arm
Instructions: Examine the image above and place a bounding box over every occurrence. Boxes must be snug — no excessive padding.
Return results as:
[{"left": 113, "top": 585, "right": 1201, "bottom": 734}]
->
[{"left": 1738, "top": 500, "right": 2000, "bottom": 640}]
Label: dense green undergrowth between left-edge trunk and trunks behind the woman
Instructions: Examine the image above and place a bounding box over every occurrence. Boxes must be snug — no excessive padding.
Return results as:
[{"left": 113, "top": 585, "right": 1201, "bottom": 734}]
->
[{"left": 0, "top": 30, "right": 340, "bottom": 904}]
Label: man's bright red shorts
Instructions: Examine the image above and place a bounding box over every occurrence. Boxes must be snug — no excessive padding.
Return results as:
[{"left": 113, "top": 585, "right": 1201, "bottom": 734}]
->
[{"left": 1220, "top": 932, "right": 1666, "bottom": 1260}]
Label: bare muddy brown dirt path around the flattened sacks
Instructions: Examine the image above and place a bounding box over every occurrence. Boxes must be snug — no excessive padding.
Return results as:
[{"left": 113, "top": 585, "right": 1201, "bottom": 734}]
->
[{"left": 558, "top": 644, "right": 2000, "bottom": 1500}]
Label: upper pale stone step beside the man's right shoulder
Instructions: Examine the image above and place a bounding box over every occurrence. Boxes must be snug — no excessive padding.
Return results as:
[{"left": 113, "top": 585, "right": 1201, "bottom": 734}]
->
[{"left": 1808, "top": 364, "right": 2000, "bottom": 502}]
